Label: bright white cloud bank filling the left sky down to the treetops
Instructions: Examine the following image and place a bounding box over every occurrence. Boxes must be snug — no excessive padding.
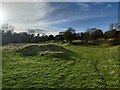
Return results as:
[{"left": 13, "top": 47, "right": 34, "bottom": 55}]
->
[{"left": 3, "top": 3, "right": 62, "bottom": 33}]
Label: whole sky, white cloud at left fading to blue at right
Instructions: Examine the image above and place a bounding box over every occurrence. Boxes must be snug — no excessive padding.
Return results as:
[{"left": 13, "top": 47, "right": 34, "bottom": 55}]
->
[{"left": 2, "top": 2, "right": 118, "bottom": 34}]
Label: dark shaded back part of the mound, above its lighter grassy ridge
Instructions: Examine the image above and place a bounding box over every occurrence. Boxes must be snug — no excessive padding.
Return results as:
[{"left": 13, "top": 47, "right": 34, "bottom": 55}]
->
[{"left": 16, "top": 44, "right": 68, "bottom": 56}]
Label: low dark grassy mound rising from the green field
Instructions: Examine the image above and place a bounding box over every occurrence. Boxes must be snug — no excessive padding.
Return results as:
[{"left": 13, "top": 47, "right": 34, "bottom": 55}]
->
[{"left": 17, "top": 44, "right": 68, "bottom": 58}]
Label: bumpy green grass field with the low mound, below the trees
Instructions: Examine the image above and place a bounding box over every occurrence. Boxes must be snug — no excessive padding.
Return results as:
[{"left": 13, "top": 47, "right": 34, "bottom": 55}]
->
[{"left": 2, "top": 44, "right": 120, "bottom": 88}]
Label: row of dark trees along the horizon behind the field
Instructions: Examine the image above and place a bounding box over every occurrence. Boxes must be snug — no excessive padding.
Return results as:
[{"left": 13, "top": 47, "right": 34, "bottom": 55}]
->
[{"left": 0, "top": 24, "right": 120, "bottom": 45}]
